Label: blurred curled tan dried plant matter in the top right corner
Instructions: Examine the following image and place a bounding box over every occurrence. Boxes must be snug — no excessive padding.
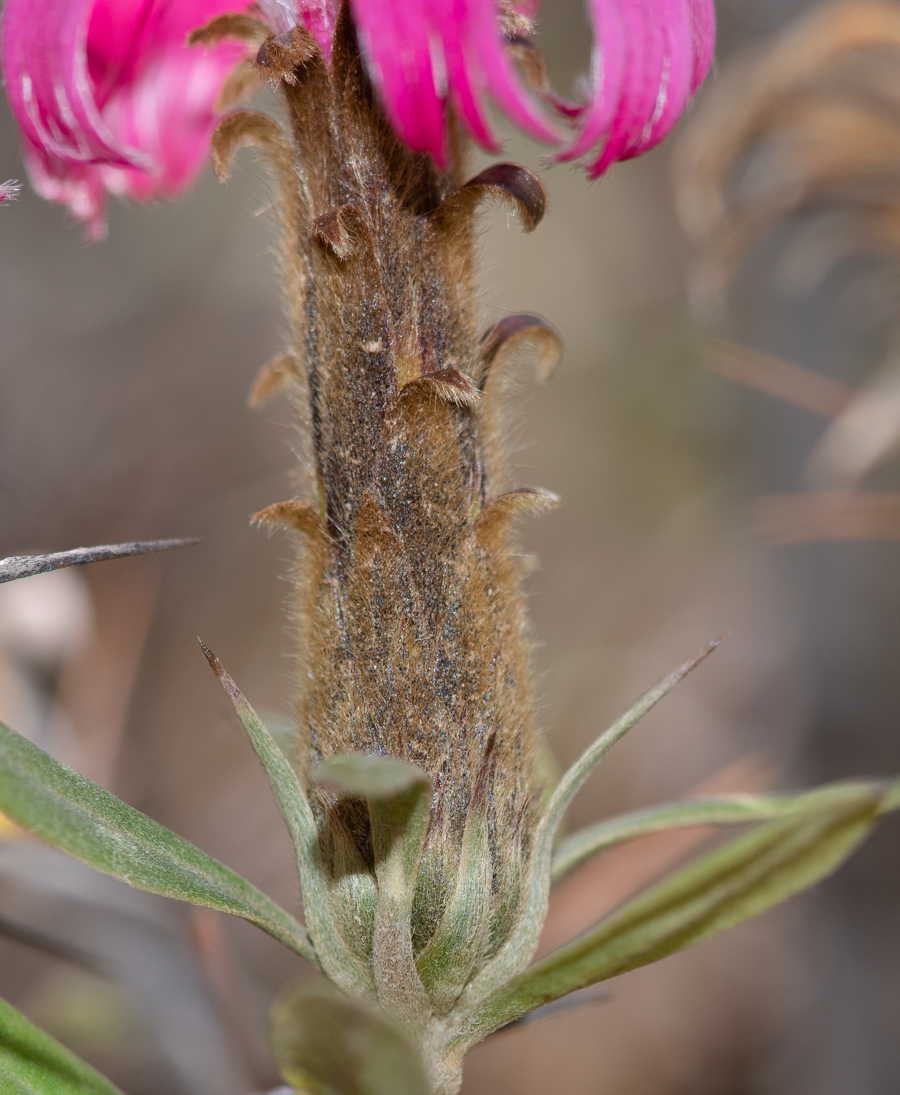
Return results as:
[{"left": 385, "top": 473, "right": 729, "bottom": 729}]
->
[{"left": 678, "top": 0, "right": 900, "bottom": 308}]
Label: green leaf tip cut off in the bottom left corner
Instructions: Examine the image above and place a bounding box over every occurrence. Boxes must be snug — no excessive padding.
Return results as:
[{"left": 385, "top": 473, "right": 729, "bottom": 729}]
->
[{"left": 0, "top": 1000, "right": 122, "bottom": 1095}]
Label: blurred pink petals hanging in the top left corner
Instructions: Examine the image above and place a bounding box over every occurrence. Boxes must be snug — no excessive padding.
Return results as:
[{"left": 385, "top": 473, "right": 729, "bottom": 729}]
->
[{"left": 2, "top": 0, "right": 251, "bottom": 237}]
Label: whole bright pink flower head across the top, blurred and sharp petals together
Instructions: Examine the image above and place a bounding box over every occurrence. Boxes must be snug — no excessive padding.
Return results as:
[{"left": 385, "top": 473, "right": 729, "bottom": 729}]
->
[{"left": 2, "top": 0, "right": 715, "bottom": 235}]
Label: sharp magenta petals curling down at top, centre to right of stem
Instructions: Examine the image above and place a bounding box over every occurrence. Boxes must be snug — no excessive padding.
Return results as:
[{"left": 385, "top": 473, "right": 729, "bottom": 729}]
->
[{"left": 282, "top": 0, "right": 715, "bottom": 177}]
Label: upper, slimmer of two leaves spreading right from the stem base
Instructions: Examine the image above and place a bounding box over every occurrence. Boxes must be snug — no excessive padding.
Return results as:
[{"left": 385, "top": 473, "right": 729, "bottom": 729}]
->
[{"left": 551, "top": 783, "right": 900, "bottom": 881}]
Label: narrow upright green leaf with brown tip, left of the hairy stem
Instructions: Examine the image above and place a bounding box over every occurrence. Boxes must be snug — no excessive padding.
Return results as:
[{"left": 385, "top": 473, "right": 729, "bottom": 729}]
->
[{"left": 200, "top": 643, "right": 374, "bottom": 996}]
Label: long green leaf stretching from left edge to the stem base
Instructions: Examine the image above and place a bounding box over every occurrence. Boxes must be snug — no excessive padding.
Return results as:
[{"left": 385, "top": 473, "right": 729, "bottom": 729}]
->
[{"left": 0, "top": 723, "right": 314, "bottom": 960}]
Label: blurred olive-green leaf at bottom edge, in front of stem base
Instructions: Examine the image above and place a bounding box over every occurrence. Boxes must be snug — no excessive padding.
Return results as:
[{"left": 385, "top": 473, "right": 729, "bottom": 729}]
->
[{"left": 272, "top": 981, "right": 429, "bottom": 1095}]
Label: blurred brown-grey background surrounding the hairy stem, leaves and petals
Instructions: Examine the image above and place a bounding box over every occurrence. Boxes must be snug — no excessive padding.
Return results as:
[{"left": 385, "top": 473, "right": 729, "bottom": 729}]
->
[{"left": 0, "top": 0, "right": 900, "bottom": 1095}]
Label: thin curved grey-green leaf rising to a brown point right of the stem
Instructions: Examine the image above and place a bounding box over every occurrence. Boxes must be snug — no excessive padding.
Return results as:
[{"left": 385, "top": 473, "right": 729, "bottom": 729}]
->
[{"left": 461, "top": 639, "right": 722, "bottom": 1007}]
